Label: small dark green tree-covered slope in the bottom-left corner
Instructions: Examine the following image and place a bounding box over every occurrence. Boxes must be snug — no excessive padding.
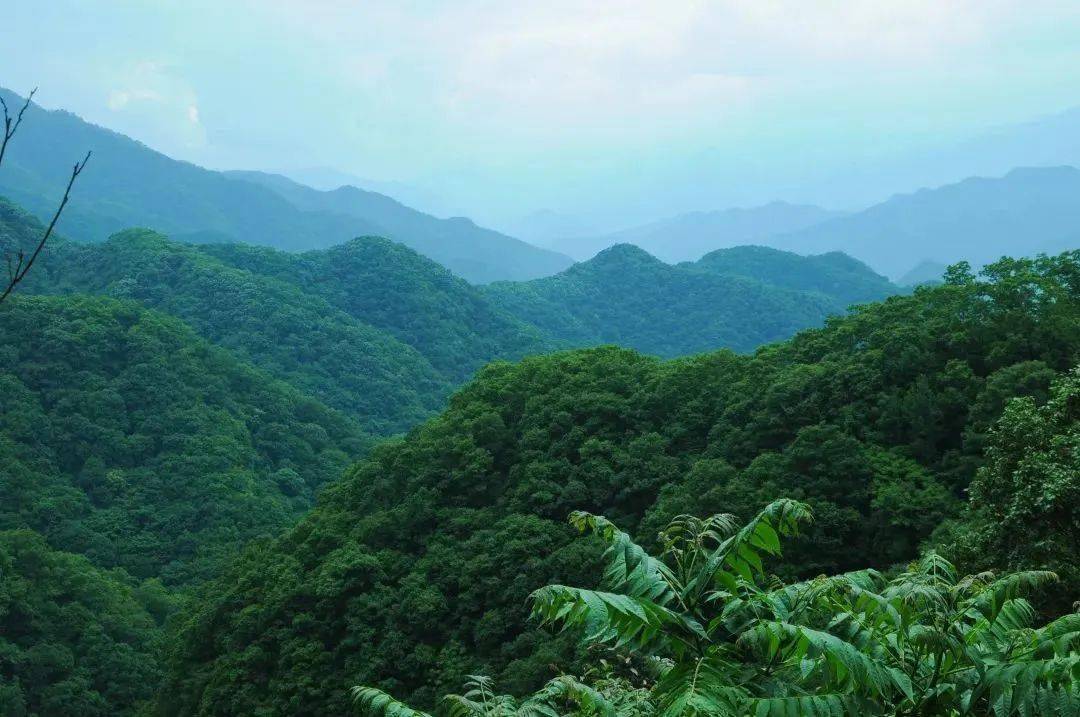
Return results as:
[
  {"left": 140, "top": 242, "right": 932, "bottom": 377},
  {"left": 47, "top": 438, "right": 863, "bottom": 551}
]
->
[{"left": 0, "top": 530, "right": 161, "bottom": 717}]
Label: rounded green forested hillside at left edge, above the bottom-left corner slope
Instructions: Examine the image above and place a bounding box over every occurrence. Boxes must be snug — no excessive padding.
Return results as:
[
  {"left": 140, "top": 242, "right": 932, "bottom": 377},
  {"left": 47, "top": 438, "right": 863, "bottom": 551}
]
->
[{"left": 0, "top": 297, "right": 368, "bottom": 585}]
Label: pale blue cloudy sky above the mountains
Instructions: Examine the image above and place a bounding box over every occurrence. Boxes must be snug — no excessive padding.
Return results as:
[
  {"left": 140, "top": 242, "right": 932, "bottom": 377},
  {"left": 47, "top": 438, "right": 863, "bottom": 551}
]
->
[{"left": 6, "top": 0, "right": 1080, "bottom": 228}]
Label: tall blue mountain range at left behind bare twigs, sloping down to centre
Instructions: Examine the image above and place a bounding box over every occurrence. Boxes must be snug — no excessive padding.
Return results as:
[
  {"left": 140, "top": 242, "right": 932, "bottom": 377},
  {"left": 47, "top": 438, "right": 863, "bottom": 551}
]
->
[{"left": 0, "top": 90, "right": 571, "bottom": 282}]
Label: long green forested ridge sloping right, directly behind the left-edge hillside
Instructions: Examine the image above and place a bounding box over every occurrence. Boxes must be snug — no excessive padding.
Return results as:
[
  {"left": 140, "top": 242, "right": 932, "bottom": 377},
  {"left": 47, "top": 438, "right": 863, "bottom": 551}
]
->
[{"left": 26, "top": 229, "right": 456, "bottom": 434}]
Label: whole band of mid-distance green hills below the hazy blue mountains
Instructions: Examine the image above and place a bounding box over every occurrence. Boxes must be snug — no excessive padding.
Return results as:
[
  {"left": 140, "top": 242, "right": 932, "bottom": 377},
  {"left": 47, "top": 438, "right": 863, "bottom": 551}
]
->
[{"left": 8, "top": 193, "right": 894, "bottom": 435}]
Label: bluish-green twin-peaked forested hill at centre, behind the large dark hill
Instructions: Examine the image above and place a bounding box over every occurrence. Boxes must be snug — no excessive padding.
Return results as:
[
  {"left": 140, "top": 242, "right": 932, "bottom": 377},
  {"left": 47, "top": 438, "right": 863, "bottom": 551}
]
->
[{"left": 484, "top": 244, "right": 893, "bottom": 356}]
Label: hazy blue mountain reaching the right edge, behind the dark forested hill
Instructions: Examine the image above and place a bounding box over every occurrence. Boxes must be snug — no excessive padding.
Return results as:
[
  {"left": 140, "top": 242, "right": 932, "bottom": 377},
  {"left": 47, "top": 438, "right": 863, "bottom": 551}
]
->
[{"left": 767, "top": 166, "right": 1080, "bottom": 276}]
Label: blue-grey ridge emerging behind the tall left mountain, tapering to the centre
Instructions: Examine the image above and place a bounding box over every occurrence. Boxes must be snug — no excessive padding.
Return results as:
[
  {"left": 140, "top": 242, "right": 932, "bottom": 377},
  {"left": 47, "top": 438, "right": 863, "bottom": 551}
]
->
[{"left": 227, "top": 172, "right": 572, "bottom": 283}]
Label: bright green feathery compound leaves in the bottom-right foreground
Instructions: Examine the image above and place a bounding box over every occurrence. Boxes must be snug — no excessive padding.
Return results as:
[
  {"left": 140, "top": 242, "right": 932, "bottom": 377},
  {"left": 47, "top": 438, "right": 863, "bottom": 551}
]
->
[{"left": 353, "top": 507, "right": 1080, "bottom": 717}]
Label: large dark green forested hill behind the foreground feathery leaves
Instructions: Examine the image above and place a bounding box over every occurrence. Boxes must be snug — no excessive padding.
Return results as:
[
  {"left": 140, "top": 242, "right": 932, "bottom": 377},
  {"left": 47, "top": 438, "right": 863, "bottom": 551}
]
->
[{"left": 159, "top": 253, "right": 1080, "bottom": 715}]
